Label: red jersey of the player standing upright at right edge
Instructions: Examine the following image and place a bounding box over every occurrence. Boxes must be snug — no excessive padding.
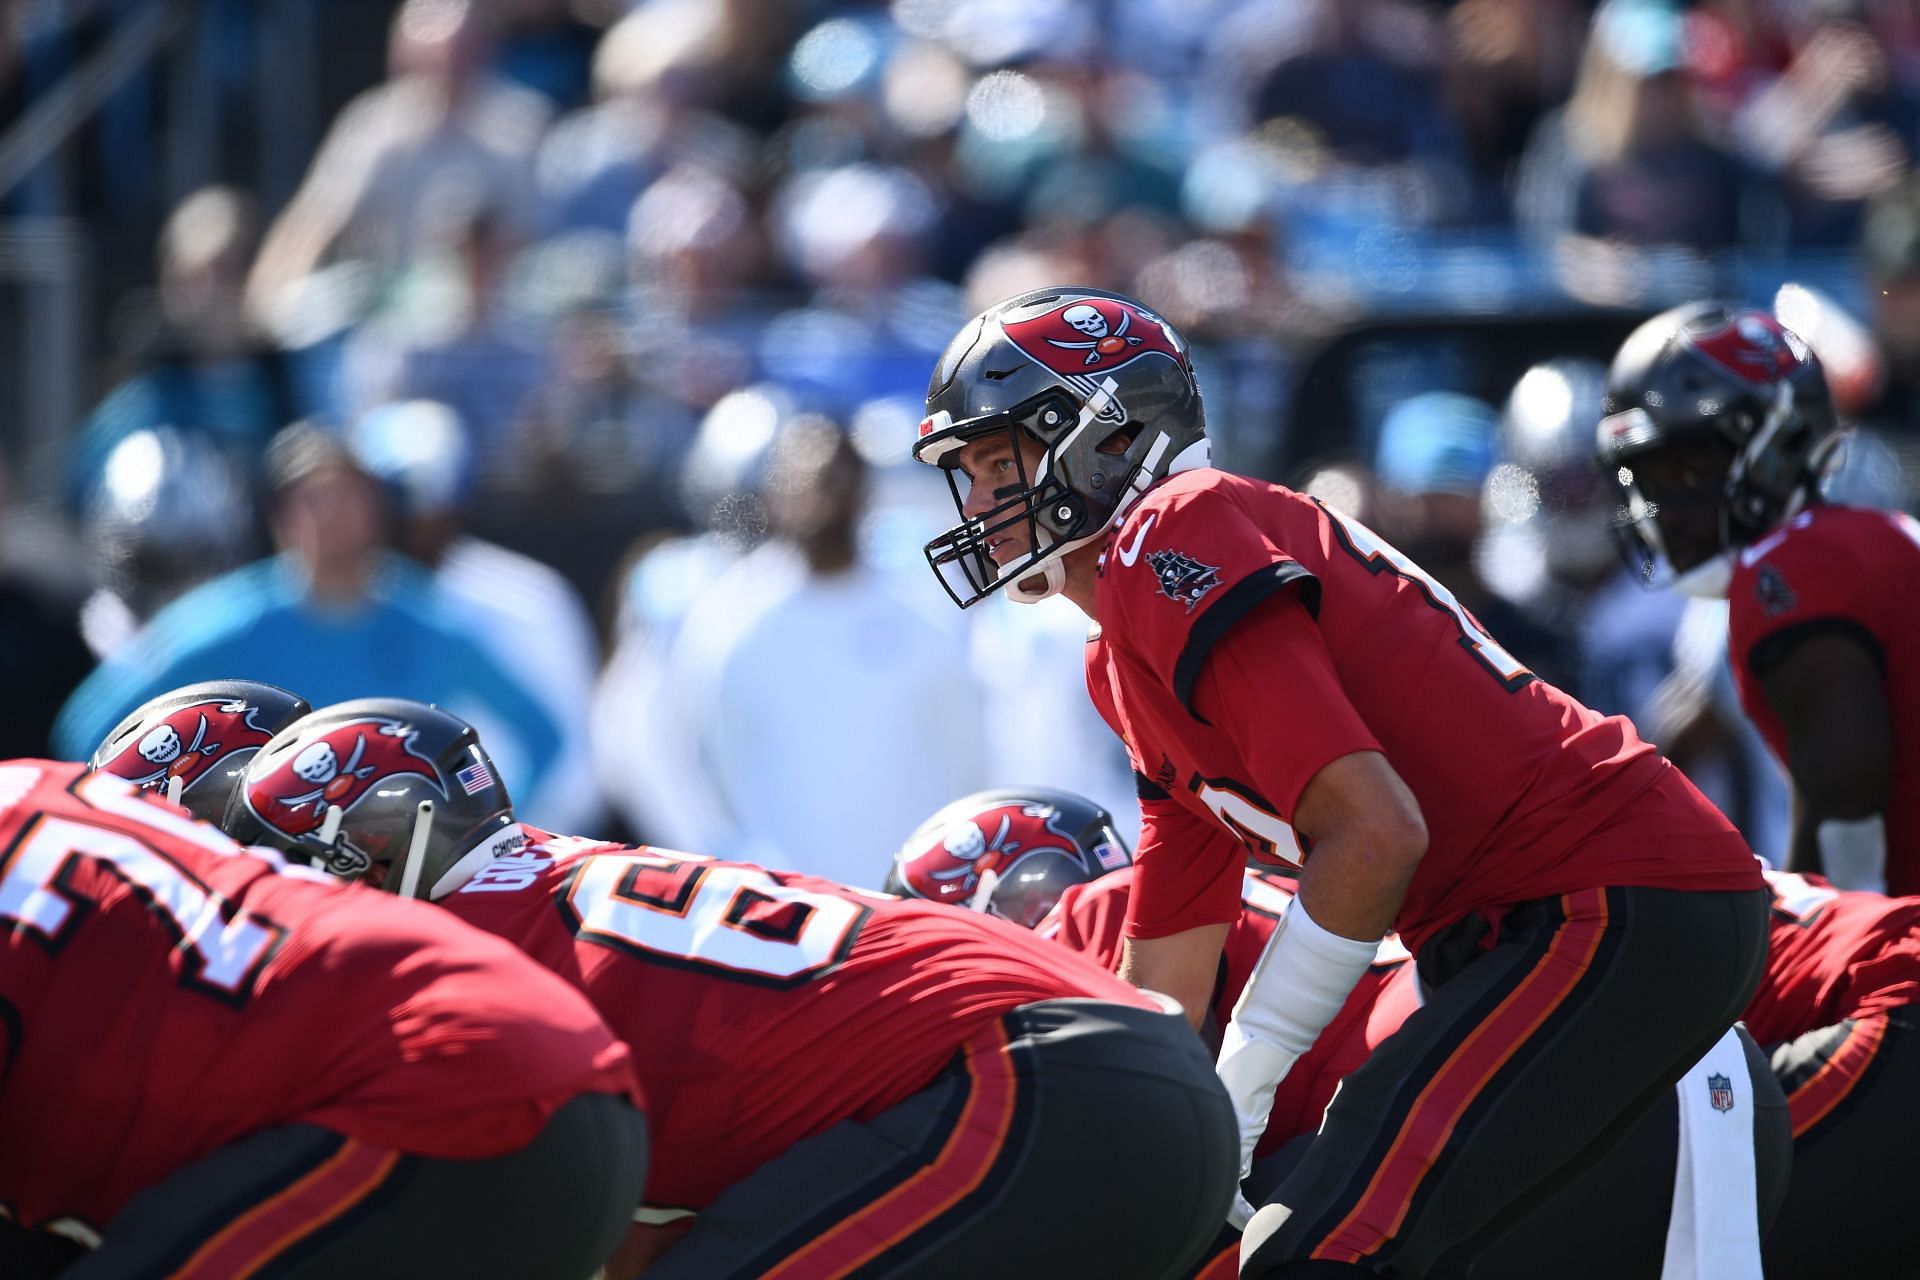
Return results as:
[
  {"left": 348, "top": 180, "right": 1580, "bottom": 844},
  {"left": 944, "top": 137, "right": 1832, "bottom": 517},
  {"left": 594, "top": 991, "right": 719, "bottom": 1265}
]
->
[{"left": 1726, "top": 507, "right": 1920, "bottom": 894}]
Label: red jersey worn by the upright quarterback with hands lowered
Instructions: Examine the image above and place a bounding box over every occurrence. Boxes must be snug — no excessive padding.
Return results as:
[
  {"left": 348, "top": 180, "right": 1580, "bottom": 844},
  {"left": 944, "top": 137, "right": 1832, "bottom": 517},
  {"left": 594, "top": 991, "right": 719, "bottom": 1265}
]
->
[{"left": 1087, "top": 468, "right": 1761, "bottom": 950}]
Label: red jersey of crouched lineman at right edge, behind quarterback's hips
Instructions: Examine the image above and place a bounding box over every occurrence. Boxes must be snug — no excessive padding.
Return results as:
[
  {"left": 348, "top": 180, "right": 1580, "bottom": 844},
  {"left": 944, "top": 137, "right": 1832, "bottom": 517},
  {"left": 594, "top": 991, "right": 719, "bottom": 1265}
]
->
[{"left": 1741, "top": 871, "right": 1920, "bottom": 1044}]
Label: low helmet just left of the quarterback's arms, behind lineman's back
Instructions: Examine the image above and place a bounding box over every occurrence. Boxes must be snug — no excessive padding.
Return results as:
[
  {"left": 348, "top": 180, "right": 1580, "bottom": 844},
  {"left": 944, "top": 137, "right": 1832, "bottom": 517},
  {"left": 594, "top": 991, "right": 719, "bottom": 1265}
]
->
[{"left": 887, "top": 787, "right": 1133, "bottom": 929}]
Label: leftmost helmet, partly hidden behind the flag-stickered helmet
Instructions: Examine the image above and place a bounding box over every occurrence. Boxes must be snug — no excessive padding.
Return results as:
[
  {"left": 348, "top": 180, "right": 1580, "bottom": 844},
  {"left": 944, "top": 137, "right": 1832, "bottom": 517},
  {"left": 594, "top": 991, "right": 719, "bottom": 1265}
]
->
[{"left": 86, "top": 679, "right": 313, "bottom": 823}]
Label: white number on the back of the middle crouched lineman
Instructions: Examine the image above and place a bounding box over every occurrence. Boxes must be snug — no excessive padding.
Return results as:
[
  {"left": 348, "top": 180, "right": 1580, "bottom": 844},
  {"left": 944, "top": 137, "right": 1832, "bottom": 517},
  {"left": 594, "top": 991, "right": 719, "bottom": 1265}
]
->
[{"left": 559, "top": 852, "right": 870, "bottom": 986}]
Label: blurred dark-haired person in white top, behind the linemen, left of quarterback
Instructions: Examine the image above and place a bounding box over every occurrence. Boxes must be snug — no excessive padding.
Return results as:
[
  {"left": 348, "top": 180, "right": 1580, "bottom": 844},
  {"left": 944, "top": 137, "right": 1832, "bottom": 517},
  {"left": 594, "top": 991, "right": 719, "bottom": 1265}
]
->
[{"left": 666, "top": 420, "right": 985, "bottom": 887}]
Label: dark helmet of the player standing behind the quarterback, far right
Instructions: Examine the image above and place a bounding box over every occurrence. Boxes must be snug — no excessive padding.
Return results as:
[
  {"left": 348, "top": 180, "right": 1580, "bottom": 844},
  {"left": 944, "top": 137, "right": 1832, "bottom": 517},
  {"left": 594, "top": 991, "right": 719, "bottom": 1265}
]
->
[{"left": 1597, "top": 303, "right": 1837, "bottom": 597}]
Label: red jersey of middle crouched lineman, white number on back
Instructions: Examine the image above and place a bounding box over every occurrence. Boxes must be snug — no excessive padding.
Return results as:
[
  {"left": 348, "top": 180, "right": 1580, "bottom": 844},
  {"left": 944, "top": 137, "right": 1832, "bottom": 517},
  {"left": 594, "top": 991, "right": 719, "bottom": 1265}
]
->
[{"left": 442, "top": 829, "right": 1160, "bottom": 1209}]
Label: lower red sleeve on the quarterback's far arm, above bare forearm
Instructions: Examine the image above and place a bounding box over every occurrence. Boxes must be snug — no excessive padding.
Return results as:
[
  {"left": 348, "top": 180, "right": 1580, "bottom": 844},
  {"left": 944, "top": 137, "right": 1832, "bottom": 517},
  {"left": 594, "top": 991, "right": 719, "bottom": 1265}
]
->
[{"left": 1125, "top": 794, "right": 1246, "bottom": 938}]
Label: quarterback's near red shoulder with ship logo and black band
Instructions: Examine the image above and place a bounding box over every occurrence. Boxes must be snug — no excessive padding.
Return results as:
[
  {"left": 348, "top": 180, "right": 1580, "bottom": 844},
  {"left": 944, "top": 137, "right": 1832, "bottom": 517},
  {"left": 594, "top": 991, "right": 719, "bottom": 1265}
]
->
[{"left": 1106, "top": 489, "right": 1319, "bottom": 708}]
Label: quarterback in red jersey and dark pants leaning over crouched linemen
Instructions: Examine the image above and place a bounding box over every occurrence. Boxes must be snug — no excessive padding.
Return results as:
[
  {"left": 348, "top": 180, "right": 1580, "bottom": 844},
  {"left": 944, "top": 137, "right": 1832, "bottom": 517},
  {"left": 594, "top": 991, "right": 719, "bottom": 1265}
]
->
[{"left": 914, "top": 288, "right": 1766, "bottom": 1276}]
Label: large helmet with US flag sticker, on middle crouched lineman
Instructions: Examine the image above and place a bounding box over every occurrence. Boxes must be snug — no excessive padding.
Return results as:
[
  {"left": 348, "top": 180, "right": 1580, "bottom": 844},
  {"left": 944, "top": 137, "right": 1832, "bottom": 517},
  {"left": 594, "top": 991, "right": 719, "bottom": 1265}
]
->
[{"left": 221, "top": 699, "right": 526, "bottom": 898}]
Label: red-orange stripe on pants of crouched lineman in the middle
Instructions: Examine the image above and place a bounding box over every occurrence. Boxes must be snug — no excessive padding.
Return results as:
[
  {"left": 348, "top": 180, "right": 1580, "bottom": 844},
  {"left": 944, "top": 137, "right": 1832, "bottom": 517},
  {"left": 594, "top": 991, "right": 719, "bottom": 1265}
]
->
[{"left": 762, "top": 1023, "right": 1020, "bottom": 1280}]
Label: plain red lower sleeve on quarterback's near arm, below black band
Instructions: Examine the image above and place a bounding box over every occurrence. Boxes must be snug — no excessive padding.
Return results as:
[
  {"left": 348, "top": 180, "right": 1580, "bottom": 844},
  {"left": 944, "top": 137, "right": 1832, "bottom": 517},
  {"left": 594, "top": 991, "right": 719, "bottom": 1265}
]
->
[{"left": 1194, "top": 595, "right": 1380, "bottom": 825}]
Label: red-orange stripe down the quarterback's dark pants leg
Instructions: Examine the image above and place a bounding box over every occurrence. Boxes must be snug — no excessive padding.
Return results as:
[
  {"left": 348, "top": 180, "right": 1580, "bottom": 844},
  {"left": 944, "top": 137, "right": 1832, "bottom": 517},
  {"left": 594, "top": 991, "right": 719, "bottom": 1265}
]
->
[{"left": 1311, "top": 889, "right": 1607, "bottom": 1263}]
